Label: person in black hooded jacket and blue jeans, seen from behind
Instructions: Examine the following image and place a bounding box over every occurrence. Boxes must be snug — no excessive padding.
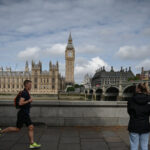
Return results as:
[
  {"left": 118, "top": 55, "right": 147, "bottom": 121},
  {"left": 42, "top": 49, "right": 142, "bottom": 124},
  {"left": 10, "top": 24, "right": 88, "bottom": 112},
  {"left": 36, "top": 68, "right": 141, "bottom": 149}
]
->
[{"left": 127, "top": 84, "right": 150, "bottom": 150}]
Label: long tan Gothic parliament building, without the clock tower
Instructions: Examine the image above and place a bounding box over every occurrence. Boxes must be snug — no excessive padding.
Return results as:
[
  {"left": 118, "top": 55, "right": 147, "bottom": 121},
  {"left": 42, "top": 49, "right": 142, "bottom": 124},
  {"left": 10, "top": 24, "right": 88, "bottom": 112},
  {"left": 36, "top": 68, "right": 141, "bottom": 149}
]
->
[{"left": 0, "top": 61, "right": 65, "bottom": 94}]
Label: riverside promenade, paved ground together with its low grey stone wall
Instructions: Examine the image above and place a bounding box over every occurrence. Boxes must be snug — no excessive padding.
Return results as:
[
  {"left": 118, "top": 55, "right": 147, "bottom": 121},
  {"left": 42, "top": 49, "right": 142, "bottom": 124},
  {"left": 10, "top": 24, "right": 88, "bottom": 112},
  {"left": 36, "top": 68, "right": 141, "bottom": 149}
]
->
[{"left": 0, "top": 100, "right": 150, "bottom": 150}]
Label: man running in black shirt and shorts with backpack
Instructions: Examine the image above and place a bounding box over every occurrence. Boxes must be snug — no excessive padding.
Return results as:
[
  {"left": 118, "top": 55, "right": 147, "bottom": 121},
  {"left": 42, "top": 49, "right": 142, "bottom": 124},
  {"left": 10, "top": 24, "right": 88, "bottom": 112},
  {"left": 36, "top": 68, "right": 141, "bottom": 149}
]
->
[{"left": 0, "top": 80, "right": 41, "bottom": 148}]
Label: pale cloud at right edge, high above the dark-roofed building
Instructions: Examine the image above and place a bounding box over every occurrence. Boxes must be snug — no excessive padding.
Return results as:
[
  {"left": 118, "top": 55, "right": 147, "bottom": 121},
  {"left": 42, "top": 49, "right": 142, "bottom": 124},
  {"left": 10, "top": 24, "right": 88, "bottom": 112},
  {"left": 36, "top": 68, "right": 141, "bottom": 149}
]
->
[{"left": 116, "top": 46, "right": 150, "bottom": 60}]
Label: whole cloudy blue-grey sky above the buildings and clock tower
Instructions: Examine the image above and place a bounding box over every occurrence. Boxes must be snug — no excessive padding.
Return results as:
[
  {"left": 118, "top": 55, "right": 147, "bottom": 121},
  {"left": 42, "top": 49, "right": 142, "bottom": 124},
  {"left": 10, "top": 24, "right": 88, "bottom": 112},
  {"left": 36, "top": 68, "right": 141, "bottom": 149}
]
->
[{"left": 0, "top": 0, "right": 150, "bottom": 83}]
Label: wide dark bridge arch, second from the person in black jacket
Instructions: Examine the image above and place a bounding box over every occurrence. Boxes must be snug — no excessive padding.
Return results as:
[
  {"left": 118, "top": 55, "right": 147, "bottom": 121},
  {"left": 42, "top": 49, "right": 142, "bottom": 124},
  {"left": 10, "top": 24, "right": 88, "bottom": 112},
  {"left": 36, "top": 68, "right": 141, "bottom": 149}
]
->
[{"left": 105, "top": 86, "right": 119, "bottom": 101}]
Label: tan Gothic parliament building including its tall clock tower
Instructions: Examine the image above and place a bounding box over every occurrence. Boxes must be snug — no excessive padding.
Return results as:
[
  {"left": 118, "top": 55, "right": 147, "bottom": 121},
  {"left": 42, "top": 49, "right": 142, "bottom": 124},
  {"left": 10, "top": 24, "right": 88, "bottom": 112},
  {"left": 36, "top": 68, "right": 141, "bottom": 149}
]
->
[{"left": 0, "top": 33, "right": 75, "bottom": 94}]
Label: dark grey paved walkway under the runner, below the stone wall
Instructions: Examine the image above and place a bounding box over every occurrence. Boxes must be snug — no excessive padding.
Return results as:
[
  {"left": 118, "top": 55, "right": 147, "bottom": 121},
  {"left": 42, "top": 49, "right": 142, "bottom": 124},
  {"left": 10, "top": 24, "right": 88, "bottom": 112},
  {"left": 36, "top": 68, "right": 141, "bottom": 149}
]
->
[{"left": 0, "top": 127, "right": 149, "bottom": 150}]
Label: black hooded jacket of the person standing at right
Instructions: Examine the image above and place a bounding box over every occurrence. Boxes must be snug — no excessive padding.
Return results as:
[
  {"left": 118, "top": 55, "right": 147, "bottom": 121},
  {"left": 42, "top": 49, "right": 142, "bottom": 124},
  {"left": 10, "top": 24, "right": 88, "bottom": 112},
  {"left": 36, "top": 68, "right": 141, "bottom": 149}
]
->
[{"left": 127, "top": 93, "right": 150, "bottom": 133}]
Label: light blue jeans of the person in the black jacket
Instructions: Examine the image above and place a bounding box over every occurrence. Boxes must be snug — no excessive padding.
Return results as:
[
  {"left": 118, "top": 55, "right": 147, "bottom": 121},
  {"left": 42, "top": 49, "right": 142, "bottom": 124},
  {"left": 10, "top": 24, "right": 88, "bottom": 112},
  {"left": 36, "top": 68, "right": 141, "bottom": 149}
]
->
[{"left": 129, "top": 133, "right": 149, "bottom": 150}]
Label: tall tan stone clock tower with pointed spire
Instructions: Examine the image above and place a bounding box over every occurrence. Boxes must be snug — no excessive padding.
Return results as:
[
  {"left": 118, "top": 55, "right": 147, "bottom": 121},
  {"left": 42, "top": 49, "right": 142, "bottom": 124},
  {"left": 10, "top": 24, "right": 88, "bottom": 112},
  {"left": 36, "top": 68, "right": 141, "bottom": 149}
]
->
[{"left": 65, "top": 33, "right": 75, "bottom": 84}]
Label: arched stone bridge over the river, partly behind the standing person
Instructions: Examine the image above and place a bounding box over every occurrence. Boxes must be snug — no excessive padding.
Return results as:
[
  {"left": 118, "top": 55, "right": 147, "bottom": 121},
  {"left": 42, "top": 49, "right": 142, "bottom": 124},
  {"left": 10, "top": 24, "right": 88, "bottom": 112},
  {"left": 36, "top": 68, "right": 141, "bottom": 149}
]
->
[{"left": 85, "top": 80, "right": 150, "bottom": 101}]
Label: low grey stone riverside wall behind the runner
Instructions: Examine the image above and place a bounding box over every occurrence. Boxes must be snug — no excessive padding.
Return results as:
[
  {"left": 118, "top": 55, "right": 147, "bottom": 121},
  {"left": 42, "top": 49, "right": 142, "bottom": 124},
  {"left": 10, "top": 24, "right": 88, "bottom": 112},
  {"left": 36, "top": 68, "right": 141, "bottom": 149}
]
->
[{"left": 0, "top": 100, "right": 129, "bottom": 126}]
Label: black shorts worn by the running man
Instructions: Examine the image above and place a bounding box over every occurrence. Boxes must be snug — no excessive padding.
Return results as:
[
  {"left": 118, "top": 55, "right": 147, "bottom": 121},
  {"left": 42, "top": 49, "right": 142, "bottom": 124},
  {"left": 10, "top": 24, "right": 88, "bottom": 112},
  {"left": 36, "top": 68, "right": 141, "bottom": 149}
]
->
[{"left": 16, "top": 110, "right": 33, "bottom": 128}]
